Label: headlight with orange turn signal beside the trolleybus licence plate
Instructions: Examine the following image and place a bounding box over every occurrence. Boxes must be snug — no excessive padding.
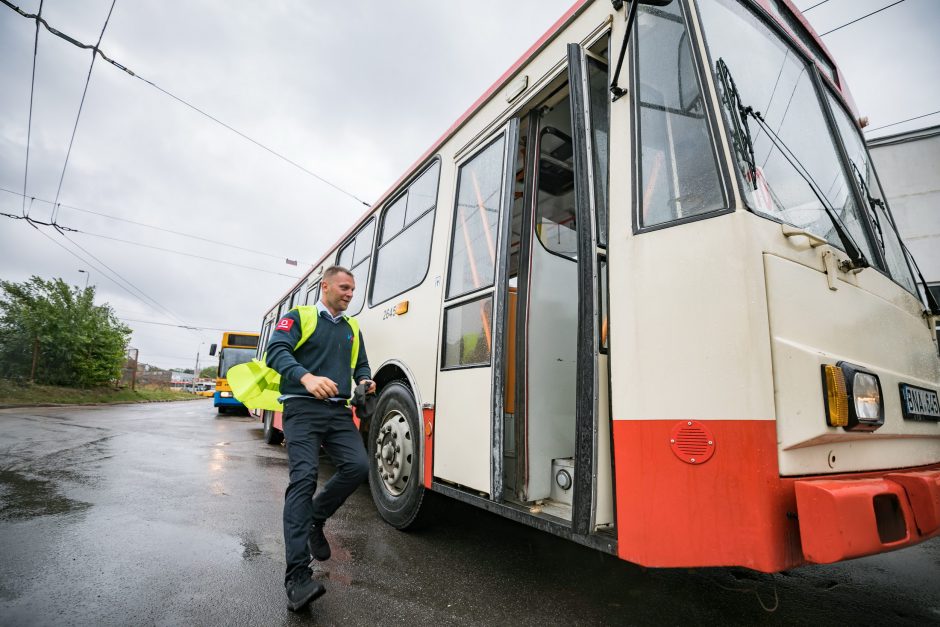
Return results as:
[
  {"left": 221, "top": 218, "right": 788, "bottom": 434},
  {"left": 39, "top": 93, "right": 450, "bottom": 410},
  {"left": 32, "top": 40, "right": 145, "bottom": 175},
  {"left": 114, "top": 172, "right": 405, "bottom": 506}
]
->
[{"left": 822, "top": 361, "right": 885, "bottom": 431}]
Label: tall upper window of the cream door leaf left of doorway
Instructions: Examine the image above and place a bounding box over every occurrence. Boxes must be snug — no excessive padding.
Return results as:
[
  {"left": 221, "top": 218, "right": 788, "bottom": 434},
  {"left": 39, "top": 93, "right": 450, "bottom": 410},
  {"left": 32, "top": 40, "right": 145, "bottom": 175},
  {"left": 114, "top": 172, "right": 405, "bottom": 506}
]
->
[{"left": 447, "top": 135, "right": 506, "bottom": 298}]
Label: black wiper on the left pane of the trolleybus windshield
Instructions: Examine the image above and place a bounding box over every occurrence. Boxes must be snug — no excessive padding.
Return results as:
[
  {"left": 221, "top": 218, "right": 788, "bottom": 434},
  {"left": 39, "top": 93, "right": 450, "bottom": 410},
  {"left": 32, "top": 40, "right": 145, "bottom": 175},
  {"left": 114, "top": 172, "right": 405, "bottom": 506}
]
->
[{"left": 715, "top": 59, "right": 871, "bottom": 272}]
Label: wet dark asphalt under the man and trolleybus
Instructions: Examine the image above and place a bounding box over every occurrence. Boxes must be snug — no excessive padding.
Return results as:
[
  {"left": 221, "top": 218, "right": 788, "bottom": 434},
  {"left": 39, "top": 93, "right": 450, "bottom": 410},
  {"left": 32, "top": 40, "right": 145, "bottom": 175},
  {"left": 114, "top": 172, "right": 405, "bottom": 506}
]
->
[{"left": 0, "top": 400, "right": 940, "bottom": 625}]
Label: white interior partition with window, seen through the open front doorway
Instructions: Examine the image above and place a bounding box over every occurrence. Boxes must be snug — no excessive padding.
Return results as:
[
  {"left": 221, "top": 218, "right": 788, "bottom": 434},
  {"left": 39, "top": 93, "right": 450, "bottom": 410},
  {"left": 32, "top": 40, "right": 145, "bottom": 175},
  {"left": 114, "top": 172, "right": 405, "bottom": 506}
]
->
[{"left": 516, "top": 93, "right": 578, "bottom": 508}]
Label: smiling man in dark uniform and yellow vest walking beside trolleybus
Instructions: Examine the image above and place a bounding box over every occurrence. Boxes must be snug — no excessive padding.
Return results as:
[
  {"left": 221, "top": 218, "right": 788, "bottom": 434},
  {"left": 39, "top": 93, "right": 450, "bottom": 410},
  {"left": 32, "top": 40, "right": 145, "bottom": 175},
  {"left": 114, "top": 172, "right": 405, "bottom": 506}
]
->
[{"left": 266, "top": 266, "right": 375, "bottom": 610}]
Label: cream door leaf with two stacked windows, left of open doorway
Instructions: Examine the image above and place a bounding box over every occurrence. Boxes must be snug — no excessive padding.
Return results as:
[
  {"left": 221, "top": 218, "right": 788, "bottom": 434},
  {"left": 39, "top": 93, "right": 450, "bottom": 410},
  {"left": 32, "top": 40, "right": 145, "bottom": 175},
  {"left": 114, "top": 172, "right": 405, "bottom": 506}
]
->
[{"left": 433, "top": 119, "right": 519, "bottom": 501}]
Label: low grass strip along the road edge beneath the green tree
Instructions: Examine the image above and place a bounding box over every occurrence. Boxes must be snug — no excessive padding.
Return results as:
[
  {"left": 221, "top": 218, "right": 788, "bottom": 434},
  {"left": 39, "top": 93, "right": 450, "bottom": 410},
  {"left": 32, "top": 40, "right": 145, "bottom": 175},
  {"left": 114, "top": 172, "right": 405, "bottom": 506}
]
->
[{"left": 0, "top": 379, "right": 202, "bottom": 405}]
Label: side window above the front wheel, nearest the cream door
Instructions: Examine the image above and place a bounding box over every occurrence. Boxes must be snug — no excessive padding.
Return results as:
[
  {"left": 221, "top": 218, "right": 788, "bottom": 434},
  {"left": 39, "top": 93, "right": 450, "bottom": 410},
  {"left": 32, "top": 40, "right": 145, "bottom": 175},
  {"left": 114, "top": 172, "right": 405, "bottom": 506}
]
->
[{"left": 370, "top": 162, "right": 441, "bottom": 305}]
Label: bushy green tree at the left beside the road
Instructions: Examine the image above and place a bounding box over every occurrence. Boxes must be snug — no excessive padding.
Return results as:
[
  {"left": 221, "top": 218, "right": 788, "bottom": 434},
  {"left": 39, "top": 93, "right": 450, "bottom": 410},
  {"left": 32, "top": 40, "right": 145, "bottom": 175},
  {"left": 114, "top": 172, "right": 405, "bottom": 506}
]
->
[{"left": 0, "top": 276, "right": 131, "bottom": 387}]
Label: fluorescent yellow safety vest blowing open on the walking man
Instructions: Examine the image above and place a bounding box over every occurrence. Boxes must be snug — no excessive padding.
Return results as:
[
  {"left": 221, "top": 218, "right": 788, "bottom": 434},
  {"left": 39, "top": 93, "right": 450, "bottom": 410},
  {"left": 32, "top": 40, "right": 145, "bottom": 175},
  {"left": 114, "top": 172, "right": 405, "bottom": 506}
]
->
[{"left": 226, "top": 305, "right": 359, "bottom": 411}]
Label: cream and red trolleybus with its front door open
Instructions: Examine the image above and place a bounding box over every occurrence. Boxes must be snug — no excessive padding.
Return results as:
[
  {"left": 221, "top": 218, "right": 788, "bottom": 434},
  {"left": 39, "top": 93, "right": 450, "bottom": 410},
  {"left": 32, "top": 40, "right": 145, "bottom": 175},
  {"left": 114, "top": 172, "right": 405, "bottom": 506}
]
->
[{"left": 250, "top": 0, "right": 940, "bottom": 572}]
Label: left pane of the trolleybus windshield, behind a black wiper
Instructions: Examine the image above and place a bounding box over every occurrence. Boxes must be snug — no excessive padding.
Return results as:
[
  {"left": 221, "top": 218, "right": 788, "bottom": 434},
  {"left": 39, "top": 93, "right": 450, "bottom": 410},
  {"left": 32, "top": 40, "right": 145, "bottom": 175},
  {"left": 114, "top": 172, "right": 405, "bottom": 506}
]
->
[{"left": 699, "top": 0, "right": 874, "bottom": 260}]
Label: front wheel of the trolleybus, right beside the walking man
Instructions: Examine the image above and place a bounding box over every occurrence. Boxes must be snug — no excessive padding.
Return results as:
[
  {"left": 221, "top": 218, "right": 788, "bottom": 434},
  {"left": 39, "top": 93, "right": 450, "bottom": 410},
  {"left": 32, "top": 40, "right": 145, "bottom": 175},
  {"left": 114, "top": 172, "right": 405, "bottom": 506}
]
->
[{"left": 369, "top": 383, "right": 424, "bottom": 529}]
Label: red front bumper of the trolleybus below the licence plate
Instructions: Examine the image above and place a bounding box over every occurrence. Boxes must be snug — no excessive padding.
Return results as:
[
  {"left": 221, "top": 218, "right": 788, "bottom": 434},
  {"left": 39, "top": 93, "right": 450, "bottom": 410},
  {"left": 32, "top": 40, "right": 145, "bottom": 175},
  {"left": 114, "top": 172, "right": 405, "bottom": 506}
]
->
[{"left": 794, "top": 469, "right": 940, "bottom": 564}]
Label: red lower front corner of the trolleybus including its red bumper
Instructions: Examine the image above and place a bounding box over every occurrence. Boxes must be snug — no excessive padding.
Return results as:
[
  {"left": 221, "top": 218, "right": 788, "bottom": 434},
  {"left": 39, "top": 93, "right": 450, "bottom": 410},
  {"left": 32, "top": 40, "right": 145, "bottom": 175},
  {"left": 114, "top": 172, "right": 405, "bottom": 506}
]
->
[{"left": 613, "top": 420, "right": 940, "bottom": 572}]
